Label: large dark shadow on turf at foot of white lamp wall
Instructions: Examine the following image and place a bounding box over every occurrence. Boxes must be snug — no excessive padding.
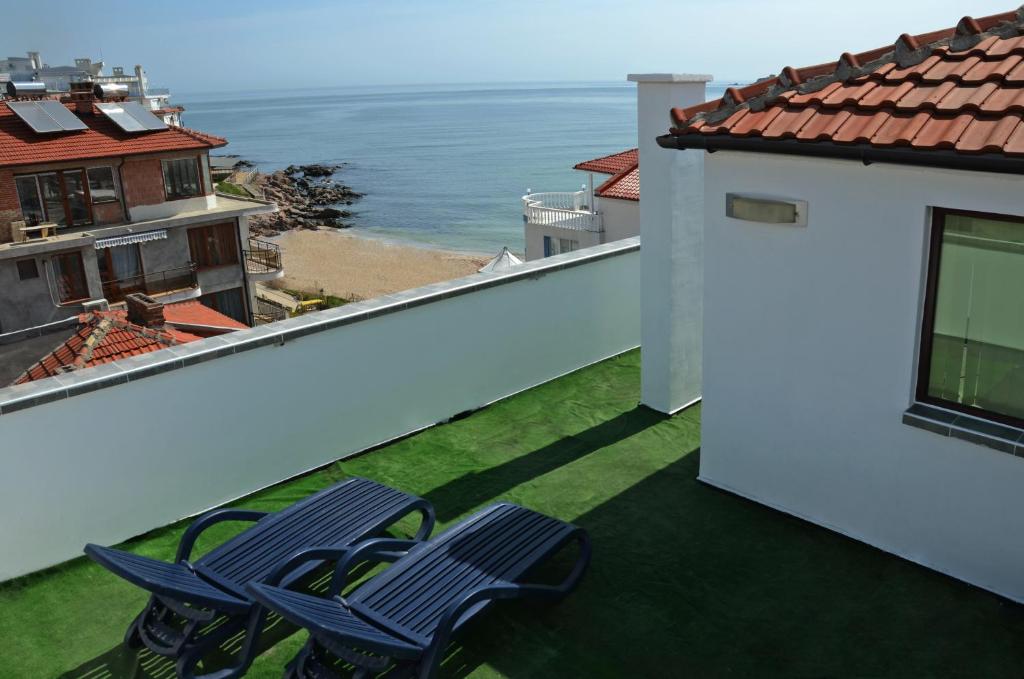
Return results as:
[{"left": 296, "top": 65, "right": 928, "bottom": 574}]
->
[{"left": 458, "top": 449, "right": 1024, "bottom": 679}]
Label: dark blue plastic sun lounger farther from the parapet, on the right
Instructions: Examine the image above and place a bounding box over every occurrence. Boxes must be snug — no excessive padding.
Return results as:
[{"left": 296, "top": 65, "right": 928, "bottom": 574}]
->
[{"left": 249, "top": 503, "right": 590, "bottom": 679}]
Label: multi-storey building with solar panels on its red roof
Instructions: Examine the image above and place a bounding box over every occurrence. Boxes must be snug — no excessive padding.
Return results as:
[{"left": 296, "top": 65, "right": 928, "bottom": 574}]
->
[{"left": 0, "top": 81, "right": 283, "bottom": 335}]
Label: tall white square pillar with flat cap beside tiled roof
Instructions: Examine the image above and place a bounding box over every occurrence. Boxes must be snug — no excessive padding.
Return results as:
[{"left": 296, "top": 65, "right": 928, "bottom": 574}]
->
[{"left": 628, "top": 74, "right": 712, "bottom": 413}]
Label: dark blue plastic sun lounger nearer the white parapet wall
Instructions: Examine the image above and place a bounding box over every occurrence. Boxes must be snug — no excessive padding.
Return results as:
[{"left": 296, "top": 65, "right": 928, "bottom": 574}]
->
[{"left": 85, "top": 478, "right": 434, "bottom": 679}]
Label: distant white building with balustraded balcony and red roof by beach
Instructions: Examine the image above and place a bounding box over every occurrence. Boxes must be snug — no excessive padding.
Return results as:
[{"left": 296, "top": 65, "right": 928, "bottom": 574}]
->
[{"left": 522, "top": 148, "right": 640, "bottom": 260}]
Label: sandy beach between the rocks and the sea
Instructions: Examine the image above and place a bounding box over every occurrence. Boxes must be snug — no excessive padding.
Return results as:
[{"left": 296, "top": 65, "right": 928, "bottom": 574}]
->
[{"left": 271, "top": 229, "right": 488, "bottom": 300}]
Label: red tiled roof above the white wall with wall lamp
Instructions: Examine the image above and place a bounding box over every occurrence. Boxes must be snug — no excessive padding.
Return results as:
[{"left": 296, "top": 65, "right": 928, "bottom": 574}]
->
[{"left": 670, "top": 9, "right": 1024, "bottom": 157}]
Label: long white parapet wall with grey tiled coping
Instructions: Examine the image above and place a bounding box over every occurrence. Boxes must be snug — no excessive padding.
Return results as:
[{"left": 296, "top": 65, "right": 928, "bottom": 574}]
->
[{"left": 0, "top": 239, "right": 640, "bottom": 580}]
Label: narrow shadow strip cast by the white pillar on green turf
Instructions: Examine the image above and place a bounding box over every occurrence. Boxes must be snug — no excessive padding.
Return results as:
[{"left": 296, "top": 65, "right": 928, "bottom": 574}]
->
[{"left": 424, "top": 406, "right": 666, "bottom": 522}]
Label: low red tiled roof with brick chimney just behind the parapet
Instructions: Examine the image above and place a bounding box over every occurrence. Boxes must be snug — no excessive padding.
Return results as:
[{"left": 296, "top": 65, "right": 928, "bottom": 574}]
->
[{"left": 14, "top": 300, "right": 247, "bottom": 384}]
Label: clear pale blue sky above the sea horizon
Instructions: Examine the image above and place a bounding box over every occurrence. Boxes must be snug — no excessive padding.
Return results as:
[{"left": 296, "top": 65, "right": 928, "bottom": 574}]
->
[{"left": 0, "top": 0, "right": 1015, "bottom": 91}]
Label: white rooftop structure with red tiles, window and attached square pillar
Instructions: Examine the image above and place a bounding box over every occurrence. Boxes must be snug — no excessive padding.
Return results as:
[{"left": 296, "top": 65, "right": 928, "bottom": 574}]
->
[{"left": 632, "top": 7, "right": 1024, "bottom": 601}]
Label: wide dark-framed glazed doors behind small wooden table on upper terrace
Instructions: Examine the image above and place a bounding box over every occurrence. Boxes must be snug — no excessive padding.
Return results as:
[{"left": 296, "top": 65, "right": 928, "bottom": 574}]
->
[{"left": 14, "top": 170, "right": 92, "bottom": 226}]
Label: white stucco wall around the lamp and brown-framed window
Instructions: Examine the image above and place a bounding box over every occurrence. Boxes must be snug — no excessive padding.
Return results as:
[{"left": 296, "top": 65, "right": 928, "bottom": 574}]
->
[{"left": 700, "top": 152, "right": 1024, "bottom": 600}]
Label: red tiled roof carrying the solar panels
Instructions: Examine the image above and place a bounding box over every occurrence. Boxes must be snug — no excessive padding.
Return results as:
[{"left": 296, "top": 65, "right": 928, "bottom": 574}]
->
[{"left": 0, "top": 103, "right": 227, "bottom": 167}]
